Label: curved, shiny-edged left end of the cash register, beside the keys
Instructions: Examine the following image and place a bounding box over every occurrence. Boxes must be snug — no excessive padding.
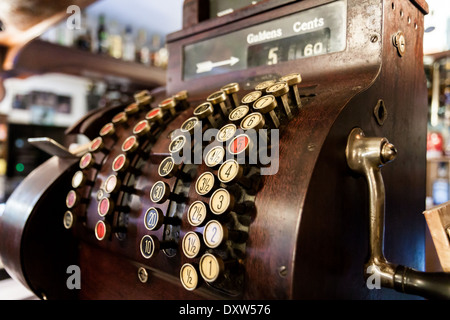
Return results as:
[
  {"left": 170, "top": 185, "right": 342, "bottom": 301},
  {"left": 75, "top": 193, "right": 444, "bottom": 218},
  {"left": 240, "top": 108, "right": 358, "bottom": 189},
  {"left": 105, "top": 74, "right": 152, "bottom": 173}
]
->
[{"left": 0, "top": 157, "right": 77, "bottom": 299}]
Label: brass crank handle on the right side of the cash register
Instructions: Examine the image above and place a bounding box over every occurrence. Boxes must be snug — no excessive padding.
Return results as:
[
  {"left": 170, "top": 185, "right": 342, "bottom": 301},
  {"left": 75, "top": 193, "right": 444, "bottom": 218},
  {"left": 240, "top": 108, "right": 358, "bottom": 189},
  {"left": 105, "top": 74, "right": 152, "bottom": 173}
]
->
[{"left": 345, "top": 128, "right": 450, "bottom": 299}]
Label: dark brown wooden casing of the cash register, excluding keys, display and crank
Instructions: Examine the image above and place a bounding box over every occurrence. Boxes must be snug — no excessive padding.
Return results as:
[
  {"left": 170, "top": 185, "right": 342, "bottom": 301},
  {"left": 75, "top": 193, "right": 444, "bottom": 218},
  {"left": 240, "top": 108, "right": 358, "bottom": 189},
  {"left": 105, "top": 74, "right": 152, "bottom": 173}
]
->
[{"left": 0, "top": 0, "right": 427, "bottom": 299}]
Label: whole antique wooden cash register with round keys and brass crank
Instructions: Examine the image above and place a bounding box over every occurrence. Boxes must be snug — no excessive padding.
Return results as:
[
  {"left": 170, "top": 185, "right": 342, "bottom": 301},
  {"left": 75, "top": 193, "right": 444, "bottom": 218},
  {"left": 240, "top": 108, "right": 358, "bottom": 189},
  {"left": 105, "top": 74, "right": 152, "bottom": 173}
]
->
[{"left": 0, "top": 0, "right": 450, "bottom": 299}]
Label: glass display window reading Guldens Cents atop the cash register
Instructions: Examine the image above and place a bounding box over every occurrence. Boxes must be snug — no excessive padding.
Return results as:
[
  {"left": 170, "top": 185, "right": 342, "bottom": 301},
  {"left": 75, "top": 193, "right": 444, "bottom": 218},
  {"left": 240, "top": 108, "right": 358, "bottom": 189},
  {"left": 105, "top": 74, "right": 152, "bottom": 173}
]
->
[{"left": 183, "top": 0, "right": 347, "bottom": 80}]
